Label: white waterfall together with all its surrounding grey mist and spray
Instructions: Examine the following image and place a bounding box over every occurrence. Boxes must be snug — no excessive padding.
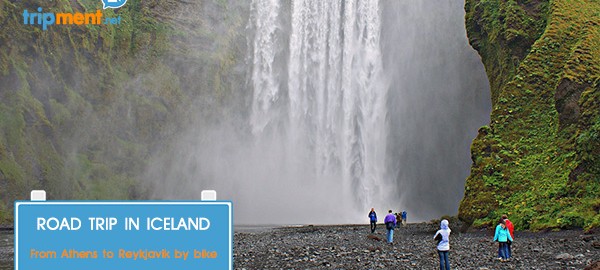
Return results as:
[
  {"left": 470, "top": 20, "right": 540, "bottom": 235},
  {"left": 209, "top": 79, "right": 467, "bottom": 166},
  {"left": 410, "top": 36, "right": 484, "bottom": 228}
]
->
[{"left": 148, "top": 0, "right": 490, "bottom": 224}]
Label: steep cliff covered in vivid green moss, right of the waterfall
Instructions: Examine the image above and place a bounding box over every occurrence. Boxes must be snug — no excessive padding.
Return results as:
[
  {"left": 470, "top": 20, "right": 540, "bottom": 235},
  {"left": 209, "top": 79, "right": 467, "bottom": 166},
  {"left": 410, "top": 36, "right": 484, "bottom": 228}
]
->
[{"left": 459, "top": 0, "right": 600, "bottom": 230}]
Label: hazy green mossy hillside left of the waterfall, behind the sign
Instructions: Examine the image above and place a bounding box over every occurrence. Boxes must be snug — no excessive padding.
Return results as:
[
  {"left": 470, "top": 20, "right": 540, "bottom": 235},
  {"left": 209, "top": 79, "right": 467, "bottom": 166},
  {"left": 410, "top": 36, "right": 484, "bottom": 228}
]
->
[{"left": 0, "top": 0, "right": 244, "bottom": 224}]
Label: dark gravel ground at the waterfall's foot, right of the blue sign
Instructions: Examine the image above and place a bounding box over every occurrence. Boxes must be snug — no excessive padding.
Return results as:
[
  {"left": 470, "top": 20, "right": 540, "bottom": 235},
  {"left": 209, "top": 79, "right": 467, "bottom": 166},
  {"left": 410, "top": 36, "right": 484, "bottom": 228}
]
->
[{"left": 234, "top": 223, "right": 600, "bottom": 270}]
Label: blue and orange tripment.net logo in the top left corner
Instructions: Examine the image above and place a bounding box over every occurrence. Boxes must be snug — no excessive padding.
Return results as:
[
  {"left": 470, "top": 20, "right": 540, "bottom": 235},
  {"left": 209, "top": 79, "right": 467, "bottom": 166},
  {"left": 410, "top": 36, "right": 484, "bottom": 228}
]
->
[{"left": 23, "top": 0, "right": 127, "bottom": 31}]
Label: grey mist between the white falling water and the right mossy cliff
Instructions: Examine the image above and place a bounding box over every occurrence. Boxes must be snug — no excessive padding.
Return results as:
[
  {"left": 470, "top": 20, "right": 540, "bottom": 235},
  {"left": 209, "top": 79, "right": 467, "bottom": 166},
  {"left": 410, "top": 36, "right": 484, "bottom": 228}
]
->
[{"left": 382, "top": 0, "right": 491, "bottom": 220}]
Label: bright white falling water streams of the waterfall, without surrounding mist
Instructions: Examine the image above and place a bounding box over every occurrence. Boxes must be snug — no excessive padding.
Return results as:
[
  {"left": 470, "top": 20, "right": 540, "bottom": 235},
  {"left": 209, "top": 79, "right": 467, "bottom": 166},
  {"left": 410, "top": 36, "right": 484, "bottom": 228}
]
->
[{"left": 250, "top": 0, "right": 393, "bottom": 213}]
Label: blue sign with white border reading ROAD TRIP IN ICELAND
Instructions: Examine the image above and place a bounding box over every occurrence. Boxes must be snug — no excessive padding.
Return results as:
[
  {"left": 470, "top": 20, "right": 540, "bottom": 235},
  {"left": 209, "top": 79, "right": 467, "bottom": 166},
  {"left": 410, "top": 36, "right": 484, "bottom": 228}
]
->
[{"left": 15, "top": 201, "right": 233, "bottom": 270}]
